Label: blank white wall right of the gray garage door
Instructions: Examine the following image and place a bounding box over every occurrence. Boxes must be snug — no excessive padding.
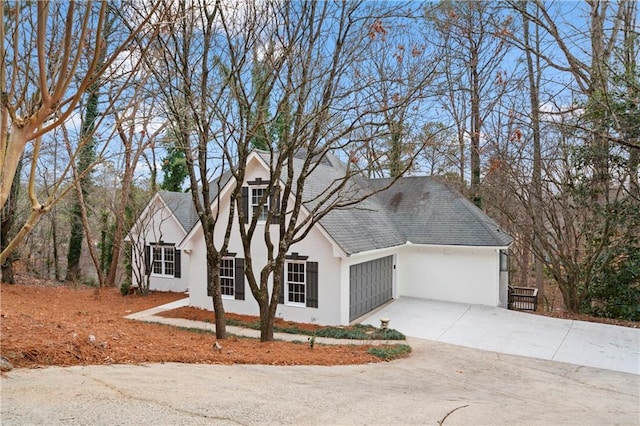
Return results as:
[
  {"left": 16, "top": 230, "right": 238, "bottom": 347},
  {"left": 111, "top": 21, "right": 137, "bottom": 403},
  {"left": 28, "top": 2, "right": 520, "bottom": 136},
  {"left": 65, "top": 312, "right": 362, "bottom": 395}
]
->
[{"left": 397, "top": 245, "right": 500, "bottom": 306}]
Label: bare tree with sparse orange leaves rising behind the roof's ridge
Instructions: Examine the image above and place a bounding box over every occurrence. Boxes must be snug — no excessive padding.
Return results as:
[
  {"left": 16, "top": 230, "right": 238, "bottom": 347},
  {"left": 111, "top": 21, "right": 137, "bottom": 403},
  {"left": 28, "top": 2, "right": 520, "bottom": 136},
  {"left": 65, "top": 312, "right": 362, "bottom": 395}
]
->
[{"left": 354, "top": 10, "right": 441, "bottom": 176}]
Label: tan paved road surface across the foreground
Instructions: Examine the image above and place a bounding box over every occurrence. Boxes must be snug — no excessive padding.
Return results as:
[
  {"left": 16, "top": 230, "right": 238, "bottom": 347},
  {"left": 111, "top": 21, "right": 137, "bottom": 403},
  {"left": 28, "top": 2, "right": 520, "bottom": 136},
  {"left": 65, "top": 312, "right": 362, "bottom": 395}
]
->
[{"left": 0, "top": 339, "right": 640, "bottom": 426}]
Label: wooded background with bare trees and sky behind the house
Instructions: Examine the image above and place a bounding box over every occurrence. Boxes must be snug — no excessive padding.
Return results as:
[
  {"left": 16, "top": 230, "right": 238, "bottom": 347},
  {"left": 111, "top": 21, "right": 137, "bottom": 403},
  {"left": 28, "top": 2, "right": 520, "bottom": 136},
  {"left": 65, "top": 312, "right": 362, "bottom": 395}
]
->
[{"left": 0, "top": 0, "right": 640, "bottom": 320}]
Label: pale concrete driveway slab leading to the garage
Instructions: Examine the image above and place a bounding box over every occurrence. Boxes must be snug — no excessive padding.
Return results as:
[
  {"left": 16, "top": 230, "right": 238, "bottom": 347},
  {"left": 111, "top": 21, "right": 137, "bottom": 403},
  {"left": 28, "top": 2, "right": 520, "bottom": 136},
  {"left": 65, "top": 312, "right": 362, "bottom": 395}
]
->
[{"left": 362, "top": 297, "right": 640, "bottom": 375}]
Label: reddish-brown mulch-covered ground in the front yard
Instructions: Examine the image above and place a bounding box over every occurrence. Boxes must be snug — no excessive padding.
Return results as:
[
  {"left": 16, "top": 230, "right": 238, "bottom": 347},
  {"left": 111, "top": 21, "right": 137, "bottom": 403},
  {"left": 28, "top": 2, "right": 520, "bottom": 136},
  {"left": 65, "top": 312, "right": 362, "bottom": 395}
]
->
[{"left": 0, "top": 276, "right": 380, "bottom": 368}]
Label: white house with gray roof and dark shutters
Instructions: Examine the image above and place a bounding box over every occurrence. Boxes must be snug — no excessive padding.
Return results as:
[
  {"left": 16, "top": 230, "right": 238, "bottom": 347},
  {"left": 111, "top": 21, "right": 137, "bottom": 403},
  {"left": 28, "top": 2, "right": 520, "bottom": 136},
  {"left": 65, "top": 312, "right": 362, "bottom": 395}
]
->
[{"left": 130, "top": 151, "right": 512, "bottom": 325}]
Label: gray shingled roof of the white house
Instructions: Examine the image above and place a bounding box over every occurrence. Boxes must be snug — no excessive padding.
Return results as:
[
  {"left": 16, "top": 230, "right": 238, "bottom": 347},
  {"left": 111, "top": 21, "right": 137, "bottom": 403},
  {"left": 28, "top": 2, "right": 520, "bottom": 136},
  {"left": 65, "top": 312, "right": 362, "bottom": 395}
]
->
[{"left": 160, "top": 152, "right": 513, "bottom": 254}]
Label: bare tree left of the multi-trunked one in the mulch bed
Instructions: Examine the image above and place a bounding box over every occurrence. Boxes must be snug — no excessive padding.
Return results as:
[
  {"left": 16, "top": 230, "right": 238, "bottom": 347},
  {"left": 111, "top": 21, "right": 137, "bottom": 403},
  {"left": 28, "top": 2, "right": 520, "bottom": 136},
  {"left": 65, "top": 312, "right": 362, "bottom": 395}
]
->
[{"left": 126, "top": 0, "right": 268, "bottom": 339}]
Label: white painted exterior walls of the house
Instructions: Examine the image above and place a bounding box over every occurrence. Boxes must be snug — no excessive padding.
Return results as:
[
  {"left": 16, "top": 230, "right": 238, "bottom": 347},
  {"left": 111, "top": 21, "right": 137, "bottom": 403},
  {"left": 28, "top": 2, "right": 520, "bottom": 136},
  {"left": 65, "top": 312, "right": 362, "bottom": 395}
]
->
[{"left": 166, "top": 155, "right": 505, "bottom": 325}]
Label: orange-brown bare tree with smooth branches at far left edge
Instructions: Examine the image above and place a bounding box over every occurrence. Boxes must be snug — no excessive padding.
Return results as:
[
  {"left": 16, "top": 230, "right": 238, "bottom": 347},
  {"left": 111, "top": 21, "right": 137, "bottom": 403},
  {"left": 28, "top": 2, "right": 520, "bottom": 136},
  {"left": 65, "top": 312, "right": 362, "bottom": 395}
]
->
[{"left": 0, "top": 1, "right": 160, "bottom": 262}]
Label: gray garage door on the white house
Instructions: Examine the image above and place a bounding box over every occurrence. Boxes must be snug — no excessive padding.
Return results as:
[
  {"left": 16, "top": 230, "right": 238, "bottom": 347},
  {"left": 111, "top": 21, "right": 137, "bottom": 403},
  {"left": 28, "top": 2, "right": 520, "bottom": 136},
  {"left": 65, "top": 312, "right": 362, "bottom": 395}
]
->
[{"left": 349, "top": 256, "right": 393, "bottom": 321}]
